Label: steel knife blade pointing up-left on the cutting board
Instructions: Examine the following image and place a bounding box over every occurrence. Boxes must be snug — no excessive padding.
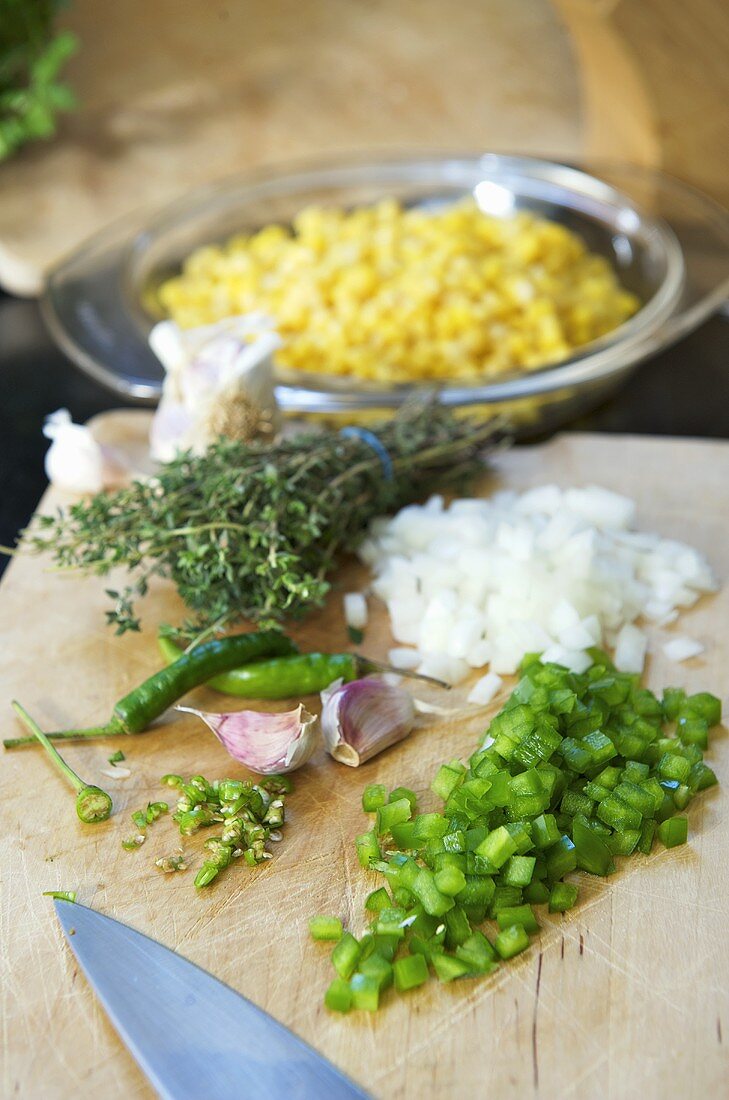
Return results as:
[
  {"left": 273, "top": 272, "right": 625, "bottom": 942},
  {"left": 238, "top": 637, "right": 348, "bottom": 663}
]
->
[{"left": 54, "top": 899, "right": 368, "bottom": 1100}]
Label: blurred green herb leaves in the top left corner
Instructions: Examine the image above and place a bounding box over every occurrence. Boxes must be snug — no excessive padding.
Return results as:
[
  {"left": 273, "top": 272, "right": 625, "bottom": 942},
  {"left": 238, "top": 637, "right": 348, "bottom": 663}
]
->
[{"left": 0, "top": 0, "right": 78, "bottom": 161}]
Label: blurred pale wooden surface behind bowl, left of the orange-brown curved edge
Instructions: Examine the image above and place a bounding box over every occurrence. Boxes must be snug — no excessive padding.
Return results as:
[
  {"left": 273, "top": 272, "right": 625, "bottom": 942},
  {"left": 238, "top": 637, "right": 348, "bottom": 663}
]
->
[{"left": 0, "top": 0, "right": 582, "bottom": 294}]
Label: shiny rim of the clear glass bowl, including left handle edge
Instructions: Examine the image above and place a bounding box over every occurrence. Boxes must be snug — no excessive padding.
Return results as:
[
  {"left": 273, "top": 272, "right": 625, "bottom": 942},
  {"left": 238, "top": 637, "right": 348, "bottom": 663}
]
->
[{"left": 42, "top": 150, "right": 685, "bottom": 411}]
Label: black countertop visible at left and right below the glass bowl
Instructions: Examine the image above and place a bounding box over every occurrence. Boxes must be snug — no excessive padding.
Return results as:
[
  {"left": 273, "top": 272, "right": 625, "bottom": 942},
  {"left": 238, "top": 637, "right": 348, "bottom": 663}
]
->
[{"left": 0, "top": 294, "right": 729, "bottom": 571}]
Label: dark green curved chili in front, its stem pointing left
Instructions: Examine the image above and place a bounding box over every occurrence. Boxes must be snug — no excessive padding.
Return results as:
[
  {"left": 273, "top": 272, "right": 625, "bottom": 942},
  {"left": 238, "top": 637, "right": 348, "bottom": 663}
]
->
[{"left": 3, "top": 630, "right": 296, "bottom": 749}]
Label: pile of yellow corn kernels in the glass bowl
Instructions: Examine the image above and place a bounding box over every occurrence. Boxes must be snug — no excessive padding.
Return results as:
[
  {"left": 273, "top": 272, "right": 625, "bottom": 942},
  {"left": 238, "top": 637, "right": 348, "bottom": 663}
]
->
[{"left": 159, "top": 200, "right": 639, "bottom": 382}]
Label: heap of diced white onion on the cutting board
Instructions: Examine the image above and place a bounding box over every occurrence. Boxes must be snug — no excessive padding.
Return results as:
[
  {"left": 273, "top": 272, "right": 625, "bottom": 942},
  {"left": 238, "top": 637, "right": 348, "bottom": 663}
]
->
[{"left": 356, "top": 485, "right": 716, "bottom": 683}]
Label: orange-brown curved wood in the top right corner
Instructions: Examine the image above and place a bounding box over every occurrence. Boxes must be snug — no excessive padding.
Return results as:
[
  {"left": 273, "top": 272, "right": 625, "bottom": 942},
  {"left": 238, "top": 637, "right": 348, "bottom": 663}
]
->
[{"left": 553, "top": 0, "right": 729, "bottom": 205}]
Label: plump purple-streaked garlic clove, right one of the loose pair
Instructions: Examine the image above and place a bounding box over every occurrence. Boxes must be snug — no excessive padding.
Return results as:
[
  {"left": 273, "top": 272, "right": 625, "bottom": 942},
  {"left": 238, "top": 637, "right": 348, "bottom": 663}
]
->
[{"left": 321, "top": 679, "right": 416, "bottom": 768}]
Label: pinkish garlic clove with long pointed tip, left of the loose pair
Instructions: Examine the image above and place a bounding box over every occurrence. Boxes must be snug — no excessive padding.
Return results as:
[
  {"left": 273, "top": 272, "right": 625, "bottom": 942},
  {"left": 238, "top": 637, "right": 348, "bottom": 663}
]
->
[{"left": 176, "top": 704, "right": 319, "bottom": 776}]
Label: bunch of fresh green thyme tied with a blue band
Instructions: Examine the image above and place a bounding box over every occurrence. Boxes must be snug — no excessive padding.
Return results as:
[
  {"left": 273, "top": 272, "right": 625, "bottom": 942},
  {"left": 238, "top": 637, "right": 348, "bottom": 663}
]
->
[{"left": 25, "top": 403, "right": 497, "bottom": 639}]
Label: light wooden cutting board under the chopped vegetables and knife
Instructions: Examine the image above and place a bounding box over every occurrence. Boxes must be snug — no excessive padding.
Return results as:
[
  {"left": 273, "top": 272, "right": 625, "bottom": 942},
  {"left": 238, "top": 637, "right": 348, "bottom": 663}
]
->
[{"left": 0, "top": 435, "right": 729, "bottom": 1100}]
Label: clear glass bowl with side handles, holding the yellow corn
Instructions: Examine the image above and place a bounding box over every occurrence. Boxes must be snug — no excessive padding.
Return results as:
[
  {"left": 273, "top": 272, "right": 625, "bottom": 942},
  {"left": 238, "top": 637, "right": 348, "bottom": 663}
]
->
[{"left": 42, "top": 154, "right": 729, "bottom": 433}]
